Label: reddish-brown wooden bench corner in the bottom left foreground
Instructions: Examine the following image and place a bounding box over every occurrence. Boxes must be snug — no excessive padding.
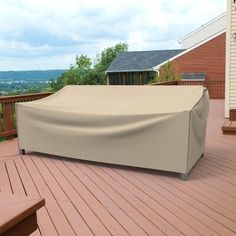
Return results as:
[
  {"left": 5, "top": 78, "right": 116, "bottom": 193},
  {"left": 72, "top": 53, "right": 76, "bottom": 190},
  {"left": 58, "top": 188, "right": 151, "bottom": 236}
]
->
[{"left": 0, "top": 193, "right": 45, "bottom": 236}]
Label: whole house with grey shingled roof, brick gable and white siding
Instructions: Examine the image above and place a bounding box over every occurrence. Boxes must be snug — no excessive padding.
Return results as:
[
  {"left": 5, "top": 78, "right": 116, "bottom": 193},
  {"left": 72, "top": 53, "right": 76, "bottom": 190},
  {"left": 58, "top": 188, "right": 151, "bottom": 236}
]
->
[{"left": 107, "top": 13, "right": 227, "bottom": 98}]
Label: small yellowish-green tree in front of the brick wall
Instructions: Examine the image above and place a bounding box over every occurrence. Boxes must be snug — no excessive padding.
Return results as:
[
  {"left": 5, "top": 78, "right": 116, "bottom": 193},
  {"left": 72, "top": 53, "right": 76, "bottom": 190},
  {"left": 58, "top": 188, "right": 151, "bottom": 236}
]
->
[{"left": 155, "top": 61, "right": 180, "bottom": 82}]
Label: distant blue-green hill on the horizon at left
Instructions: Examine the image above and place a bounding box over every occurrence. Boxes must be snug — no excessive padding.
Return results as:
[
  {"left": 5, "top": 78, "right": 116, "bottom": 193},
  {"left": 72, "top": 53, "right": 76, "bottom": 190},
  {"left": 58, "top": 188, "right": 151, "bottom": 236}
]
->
[{"left": 0, "top": 70, "right": 66, "bottom": 95}]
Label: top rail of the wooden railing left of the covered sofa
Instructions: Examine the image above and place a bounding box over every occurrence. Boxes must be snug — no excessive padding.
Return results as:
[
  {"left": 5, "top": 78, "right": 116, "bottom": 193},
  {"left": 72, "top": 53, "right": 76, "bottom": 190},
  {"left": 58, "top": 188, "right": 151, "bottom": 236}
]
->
[{"left": 0, "top": 92, "right": 53, "bottom": 103}]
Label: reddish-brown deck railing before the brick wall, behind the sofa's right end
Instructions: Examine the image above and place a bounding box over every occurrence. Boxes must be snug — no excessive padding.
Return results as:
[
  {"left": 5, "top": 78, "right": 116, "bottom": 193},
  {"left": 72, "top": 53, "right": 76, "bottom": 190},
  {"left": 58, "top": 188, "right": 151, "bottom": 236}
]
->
[{"left": 153, "top": 80, "right": 225, "bottom": 99}]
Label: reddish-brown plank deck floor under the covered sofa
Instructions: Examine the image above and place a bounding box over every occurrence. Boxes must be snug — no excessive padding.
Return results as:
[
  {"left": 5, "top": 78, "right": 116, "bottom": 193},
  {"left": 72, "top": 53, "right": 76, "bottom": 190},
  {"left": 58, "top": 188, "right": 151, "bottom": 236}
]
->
[{"left": 0, "top": 100, "right": 236, "bottom": 236}]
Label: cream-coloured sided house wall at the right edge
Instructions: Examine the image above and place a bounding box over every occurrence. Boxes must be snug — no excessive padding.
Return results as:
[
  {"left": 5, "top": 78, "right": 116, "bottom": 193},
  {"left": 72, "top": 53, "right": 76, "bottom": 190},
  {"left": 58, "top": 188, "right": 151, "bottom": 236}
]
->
[{"left": 225, "top": 0, "right": 236, "bottom": 117}]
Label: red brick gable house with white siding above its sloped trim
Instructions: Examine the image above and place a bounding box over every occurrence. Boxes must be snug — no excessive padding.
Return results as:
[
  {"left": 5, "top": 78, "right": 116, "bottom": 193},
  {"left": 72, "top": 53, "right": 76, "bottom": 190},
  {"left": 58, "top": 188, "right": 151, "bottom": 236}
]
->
[{"left": 155, "top": 13, "right": 227, "bottom": 98}]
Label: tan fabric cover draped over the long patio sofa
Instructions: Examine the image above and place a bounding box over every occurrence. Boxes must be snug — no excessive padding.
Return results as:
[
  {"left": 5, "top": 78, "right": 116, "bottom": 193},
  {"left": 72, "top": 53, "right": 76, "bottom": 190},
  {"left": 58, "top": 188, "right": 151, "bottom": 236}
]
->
[{"left": 16, "top": 86, "right": 209, "bottom": 173}]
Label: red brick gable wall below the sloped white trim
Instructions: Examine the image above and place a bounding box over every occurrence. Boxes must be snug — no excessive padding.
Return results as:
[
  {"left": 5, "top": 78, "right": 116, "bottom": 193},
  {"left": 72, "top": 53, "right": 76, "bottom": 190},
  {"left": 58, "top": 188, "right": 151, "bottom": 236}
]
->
[{"left": 173, "top": 33, "right": 226, "bottom": 98}]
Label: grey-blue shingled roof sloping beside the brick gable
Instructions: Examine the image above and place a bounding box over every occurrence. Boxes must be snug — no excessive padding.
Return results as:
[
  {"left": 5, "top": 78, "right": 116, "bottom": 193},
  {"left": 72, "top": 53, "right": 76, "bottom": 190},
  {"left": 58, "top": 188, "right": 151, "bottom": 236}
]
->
[{"left": 106, "top": 49, "right": 184, "bottom": 73}]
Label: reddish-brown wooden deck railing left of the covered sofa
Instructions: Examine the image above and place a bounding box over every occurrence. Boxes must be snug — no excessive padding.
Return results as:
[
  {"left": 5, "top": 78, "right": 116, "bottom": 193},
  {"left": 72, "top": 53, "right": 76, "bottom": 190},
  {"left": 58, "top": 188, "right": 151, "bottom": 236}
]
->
[{"left": 0, "top": 93, "right": 52, "bottom": 138}]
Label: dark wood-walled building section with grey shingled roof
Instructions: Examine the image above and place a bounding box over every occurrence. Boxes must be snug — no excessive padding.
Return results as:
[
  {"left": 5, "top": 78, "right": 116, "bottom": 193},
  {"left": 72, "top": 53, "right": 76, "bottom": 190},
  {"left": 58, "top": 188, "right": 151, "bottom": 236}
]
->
[{"left": 106, "top": 49, "right": 184, "bottom": 85}]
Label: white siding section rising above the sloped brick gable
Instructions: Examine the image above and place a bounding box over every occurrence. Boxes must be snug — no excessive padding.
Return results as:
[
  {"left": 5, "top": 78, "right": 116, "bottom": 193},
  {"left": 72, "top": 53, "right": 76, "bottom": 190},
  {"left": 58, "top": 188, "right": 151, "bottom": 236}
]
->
[{"left": 179, "top": 13, "right": 227, "bottom": 49}]
